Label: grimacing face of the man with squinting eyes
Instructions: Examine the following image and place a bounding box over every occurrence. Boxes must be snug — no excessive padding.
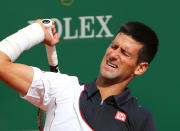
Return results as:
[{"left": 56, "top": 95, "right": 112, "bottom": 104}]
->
[{"left": 100, "top": 33, "right": 143, "bottom": 81}]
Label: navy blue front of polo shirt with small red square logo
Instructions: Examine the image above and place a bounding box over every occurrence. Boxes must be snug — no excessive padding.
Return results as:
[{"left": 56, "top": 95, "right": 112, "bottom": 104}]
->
[{"left": 80, "top": 81, "right": 156, "bottom": 131}]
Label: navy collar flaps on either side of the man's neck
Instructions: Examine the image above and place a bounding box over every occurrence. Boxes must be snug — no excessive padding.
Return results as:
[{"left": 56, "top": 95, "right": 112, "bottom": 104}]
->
[{"left": 86, "top": 79, "right": 132, "bottom": 106}]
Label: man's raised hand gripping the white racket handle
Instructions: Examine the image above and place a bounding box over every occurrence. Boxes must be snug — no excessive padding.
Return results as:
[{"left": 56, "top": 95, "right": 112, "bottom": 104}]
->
[{"left": 35, "top": 19, "right": 59, "bottom": 46}]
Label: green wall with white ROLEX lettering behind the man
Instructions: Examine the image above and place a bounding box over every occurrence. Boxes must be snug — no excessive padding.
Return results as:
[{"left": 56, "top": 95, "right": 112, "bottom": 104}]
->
[{"left": 0, "top": 0, "right": 180, "bottom": 131}]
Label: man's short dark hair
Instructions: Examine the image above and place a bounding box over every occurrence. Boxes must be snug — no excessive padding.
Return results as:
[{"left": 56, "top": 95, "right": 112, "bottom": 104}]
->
[{"left": 119, "top": 22, "right": 159, "bottom": 63}]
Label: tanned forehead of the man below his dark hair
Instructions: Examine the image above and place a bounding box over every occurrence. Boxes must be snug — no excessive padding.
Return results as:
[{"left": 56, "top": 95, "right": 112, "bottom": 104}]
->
[{"left": 112, "top": 33, "right": 143, "bottom": 51}]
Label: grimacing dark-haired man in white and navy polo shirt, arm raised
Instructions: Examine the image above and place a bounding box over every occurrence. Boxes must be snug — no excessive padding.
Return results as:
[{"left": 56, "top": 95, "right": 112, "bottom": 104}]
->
[{"left": 0, "top": 20, "right": 158, "bottom": 131}]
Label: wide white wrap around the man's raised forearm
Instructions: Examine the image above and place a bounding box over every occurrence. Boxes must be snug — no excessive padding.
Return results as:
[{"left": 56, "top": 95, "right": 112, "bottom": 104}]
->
[{"left": 0, "top": 23, "right": 44, "bottom": 62}]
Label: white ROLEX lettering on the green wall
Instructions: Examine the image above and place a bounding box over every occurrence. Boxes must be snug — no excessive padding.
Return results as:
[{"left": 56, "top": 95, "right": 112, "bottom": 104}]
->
[{"left": 28, "top": 15, "right": 113, "bottom": 40}]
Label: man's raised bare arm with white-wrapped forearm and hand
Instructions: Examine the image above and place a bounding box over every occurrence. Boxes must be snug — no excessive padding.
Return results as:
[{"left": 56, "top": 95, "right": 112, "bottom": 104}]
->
[{"left": 0, "top": 20, "right": 59, "bottom": 95}]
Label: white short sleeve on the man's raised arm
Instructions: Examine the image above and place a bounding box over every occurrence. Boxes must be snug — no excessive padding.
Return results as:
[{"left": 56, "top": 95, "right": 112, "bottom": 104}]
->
[{"left": 22, "top": 67, "right": 77, "bottom": 111}]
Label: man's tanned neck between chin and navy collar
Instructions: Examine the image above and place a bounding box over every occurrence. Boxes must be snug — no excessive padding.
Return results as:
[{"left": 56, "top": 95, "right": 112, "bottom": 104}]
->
[{"left": 96, "top": 76, "right": 133, "bottom": 100}]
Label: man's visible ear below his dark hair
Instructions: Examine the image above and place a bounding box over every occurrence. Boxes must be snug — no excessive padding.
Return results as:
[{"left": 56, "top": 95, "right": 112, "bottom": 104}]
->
[{"left": 134, "top": 62, "right": 149, "bottom": 75}]
